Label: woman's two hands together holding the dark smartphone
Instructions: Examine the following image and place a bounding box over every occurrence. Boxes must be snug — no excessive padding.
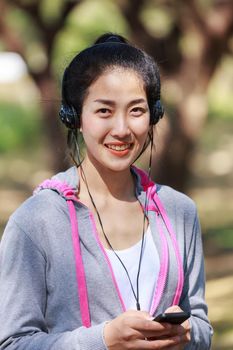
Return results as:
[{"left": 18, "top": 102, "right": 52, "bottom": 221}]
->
[{"left": 104, "top": 310, "right": 185, "bottom": 350}]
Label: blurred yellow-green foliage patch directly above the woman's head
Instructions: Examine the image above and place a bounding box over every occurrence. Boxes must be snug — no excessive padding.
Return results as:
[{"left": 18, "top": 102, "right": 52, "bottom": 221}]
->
[{"left": 53, "top": 0, "right": 129, "bottom": 75}]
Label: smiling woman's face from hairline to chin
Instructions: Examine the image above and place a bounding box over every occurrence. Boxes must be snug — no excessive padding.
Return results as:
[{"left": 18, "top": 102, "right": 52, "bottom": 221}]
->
[{"left": 81, "top": 67, "right": 150, "bottom": 171}]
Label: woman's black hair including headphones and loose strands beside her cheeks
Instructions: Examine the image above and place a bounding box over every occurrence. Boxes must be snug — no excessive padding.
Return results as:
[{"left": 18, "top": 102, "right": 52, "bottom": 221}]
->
[{"left": 59, "top": 33, "right": 164, "bottom": 166}]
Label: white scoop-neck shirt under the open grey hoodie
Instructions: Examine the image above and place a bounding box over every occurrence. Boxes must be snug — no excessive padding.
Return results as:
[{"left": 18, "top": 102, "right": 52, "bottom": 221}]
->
[{"left": 106, "top": 226, "right": 160, "bottom": 312}]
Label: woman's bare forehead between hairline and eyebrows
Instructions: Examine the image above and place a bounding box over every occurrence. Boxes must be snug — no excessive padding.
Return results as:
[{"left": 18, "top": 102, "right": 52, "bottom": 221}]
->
[{"left": 87, "top": 67, "right": 146, "bottom": 98}]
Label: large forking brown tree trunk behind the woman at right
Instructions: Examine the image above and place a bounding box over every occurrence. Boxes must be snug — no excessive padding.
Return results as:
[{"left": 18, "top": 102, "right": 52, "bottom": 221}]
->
[{"left": 118, "top": 0, "right": 233, "bottom": 191}]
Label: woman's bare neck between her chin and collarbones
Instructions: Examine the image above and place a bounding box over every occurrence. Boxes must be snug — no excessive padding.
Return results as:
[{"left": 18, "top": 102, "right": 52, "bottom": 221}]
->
[{"left": 79, "top": 157, "right": 135, "bottom": 200}]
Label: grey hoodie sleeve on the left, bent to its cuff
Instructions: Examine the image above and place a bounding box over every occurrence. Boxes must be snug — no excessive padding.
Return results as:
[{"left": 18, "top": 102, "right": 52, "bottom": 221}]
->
[{"left": 0, "top": 219, "right": 106, "bottom": 350}]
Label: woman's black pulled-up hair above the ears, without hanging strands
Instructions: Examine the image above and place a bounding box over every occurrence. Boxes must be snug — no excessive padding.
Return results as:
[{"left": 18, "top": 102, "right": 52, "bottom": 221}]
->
[{"left": 62, "top": 33, "right": 160, "bottom": 118}]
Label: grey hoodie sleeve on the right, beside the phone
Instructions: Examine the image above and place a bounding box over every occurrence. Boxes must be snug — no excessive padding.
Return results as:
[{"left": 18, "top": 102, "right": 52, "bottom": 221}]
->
[{"left": 180, "top": 213, "right": 213, "bottom": 350}]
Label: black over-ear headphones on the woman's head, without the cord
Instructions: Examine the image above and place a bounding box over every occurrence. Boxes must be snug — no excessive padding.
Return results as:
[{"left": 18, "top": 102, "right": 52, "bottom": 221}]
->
[{"left": 59, "top": 69, "right": 164, "bottom": 129}]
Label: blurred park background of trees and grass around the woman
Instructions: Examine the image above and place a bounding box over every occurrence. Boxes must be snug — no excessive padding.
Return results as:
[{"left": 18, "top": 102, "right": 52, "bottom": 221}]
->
[{"left": 0, "top": 0, "right": 233, "bottom": 350}]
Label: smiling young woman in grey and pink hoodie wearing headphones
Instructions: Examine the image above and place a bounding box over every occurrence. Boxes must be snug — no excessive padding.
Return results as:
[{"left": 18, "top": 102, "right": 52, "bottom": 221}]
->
[{"left": 0, "top": 34, "right": 212, "bottom": 350}]
